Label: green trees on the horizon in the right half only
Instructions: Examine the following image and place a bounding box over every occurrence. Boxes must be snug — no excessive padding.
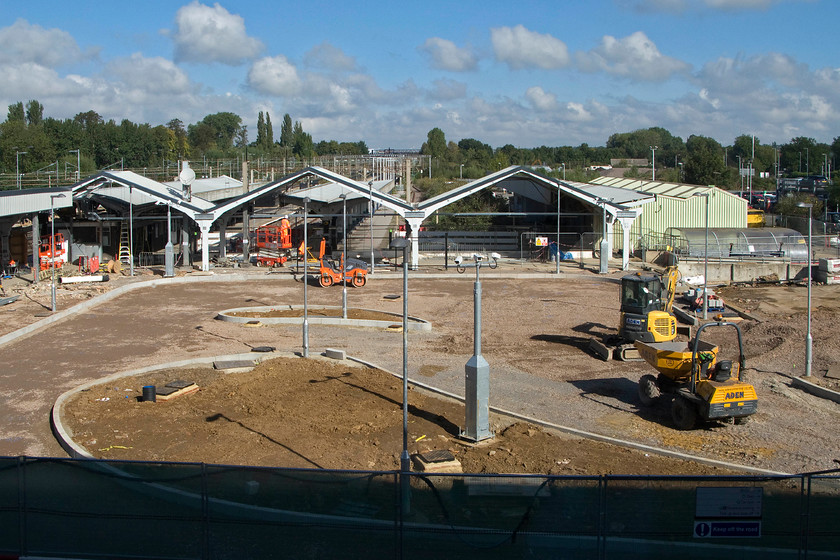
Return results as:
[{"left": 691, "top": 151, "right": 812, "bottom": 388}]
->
[{"left": 421, "top": 127, "right": 840, "bottom": 190}]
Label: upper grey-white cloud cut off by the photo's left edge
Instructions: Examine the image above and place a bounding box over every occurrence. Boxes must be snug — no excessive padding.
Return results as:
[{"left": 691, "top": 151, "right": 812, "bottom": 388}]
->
[{"left": 0, "top": 19, "right": 95, "bottom": 68}]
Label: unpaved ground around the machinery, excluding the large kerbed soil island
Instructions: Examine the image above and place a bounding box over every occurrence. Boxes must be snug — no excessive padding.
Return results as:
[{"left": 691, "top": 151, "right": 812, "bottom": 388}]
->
[{"left": 0, "top": 264, "right": 840, "bottom": 472}]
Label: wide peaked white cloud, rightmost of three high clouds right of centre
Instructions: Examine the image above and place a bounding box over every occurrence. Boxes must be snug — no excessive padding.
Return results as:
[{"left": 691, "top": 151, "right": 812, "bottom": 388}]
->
[{"left": 575, "top": 31, "right": 690, "bottom": 82}]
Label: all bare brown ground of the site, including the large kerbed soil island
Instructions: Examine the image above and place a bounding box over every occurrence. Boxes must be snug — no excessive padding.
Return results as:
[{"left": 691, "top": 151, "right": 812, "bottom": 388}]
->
[{"left": 0, "top": 266, "right": 840, "bottom": 474}]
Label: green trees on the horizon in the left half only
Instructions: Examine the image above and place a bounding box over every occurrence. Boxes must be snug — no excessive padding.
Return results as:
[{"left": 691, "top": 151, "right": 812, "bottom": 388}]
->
[{"left": 0, "top": 100, "right": 368, "bottom": 182}]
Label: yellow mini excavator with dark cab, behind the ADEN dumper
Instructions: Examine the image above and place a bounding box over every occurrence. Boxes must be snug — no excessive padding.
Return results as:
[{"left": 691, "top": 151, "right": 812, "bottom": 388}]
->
[{"left": 589, "top": 266, "right": 679, "bottom": 361}]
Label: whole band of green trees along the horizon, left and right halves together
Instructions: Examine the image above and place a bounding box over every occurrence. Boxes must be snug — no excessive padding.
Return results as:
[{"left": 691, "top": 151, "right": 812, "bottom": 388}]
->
[{"left": 0, "top": 100, "right": 840, "bottom": 196}]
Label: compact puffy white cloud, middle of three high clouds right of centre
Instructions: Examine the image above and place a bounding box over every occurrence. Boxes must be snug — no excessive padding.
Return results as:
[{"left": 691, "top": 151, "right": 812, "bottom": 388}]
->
[{"left": 490, "top": 25, "right": 569, "bottom": 70}]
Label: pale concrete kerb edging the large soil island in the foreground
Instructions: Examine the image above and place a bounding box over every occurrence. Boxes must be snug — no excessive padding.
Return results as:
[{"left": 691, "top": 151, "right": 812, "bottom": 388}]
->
[{"left": 50, "top": 352, "right": 789, "bottom": 476}]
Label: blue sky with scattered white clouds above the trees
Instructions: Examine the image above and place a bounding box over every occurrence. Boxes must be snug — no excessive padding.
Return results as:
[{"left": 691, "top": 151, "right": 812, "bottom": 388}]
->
[{"left": 0, "top": 0, "right": 840, "bottom": 149}]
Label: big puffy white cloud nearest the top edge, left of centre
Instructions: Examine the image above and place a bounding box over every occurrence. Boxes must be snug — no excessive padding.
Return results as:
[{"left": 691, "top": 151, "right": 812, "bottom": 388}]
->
[{"left": 170, "top": 0, "right": 263, "bottom": 66}]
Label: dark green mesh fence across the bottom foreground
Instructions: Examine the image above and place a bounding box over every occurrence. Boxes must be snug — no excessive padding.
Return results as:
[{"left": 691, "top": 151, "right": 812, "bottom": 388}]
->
[{"left": 0, "top": 457, "right": 840, "bottom": 560}]
